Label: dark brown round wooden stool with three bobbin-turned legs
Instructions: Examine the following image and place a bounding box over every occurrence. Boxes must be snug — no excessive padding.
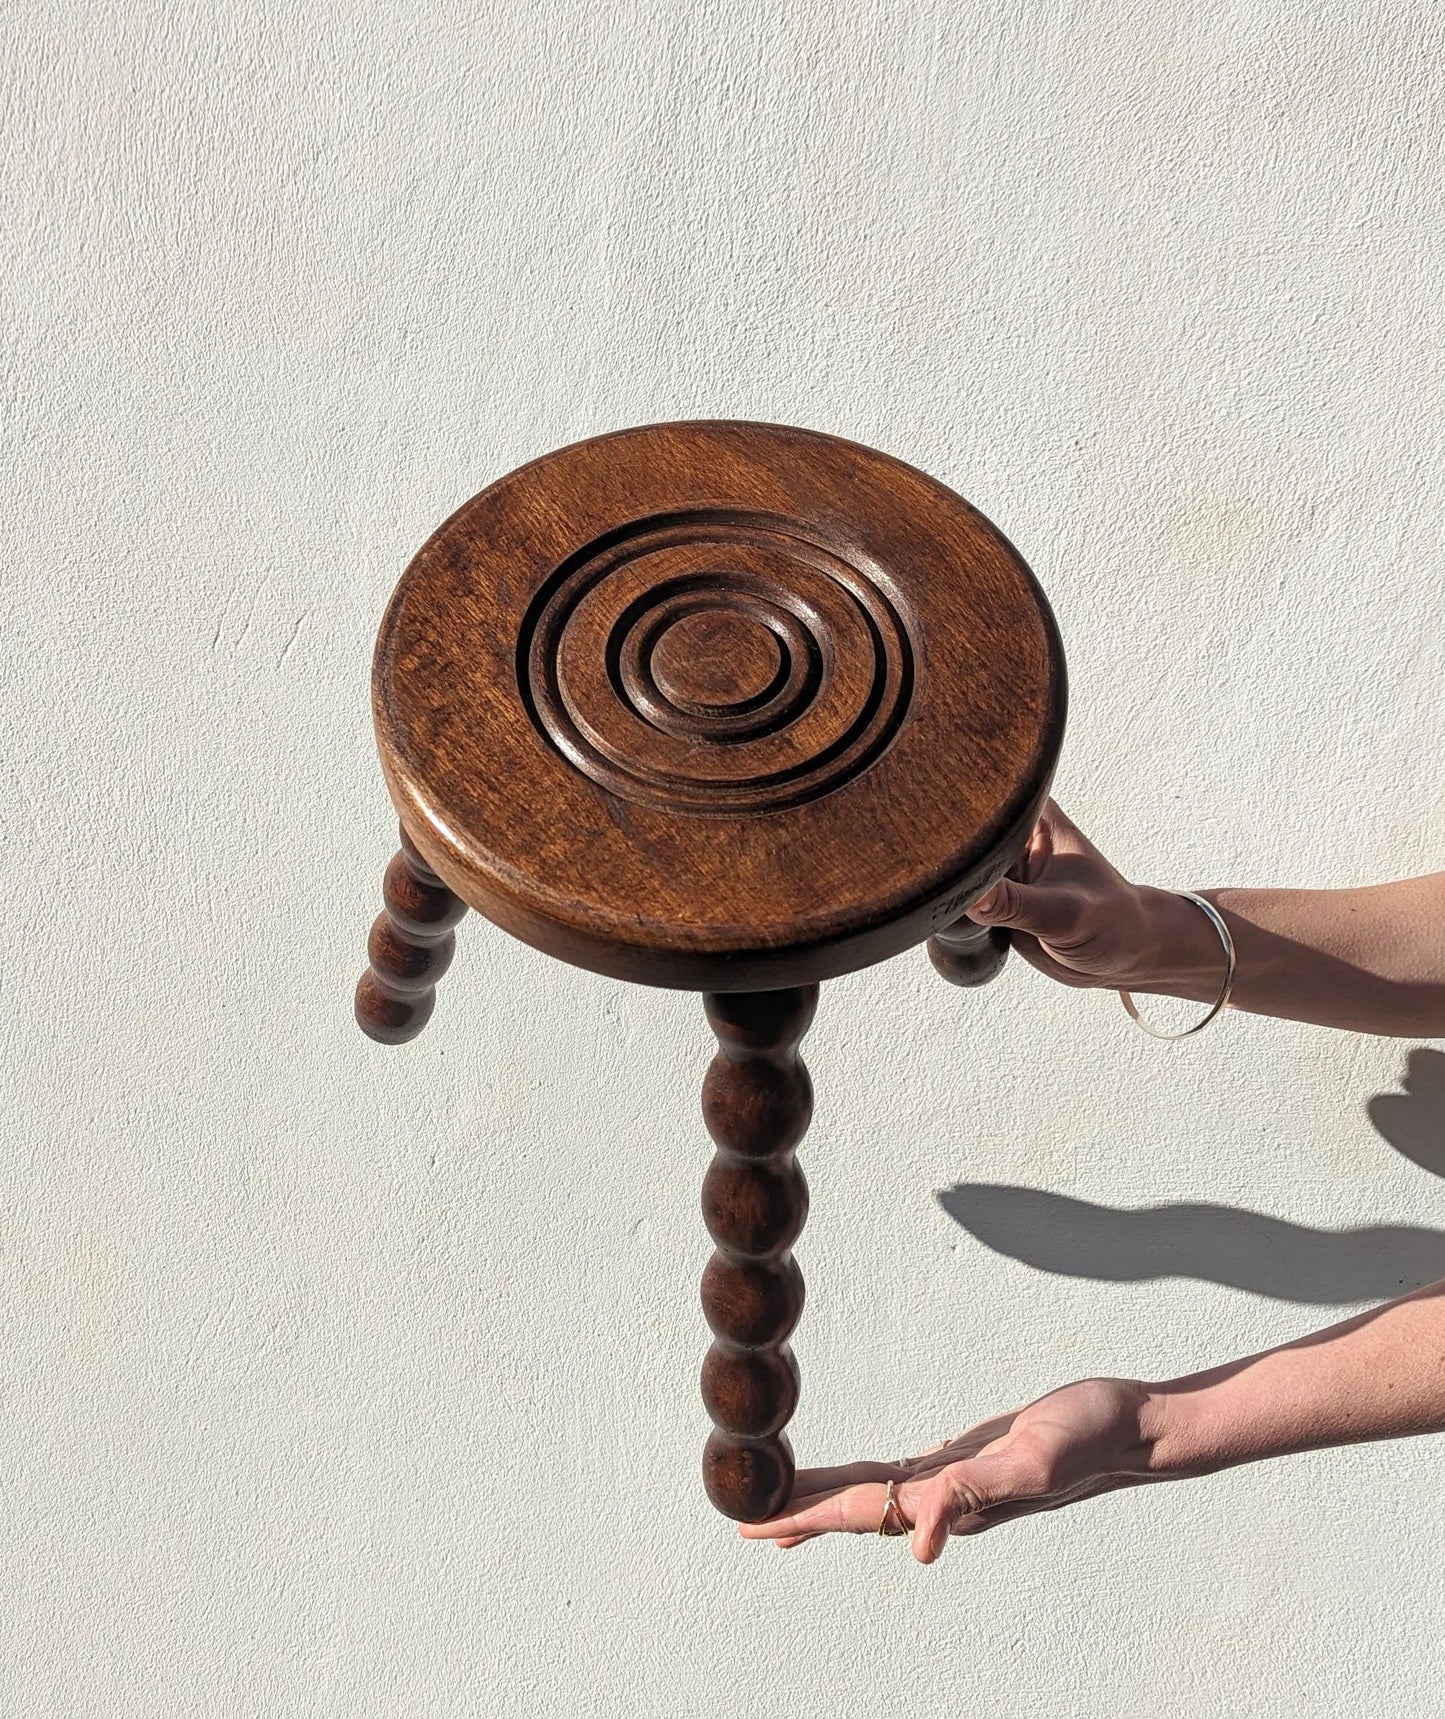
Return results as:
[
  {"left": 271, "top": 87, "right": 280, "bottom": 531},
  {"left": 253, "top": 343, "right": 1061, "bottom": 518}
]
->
[{"left": 356, "top": 423, "right": 1065, "bottom": 1521}]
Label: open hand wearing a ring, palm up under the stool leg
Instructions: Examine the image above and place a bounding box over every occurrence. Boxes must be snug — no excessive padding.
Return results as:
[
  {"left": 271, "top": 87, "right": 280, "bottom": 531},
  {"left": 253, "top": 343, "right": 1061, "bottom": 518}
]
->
[{"left": 739, "top": 1379, "right": 1165, "bottom": 1564}]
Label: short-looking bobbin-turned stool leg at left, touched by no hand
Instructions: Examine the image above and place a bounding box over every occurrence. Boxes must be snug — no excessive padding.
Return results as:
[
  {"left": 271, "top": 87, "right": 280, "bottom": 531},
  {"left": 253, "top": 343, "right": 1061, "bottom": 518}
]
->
[{"left": 356, "top": 827, "right": 467, "bottom": 1045}]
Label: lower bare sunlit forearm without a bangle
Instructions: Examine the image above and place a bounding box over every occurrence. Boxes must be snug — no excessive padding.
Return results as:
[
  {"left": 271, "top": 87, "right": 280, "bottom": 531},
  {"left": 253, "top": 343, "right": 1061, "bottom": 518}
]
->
[{"left": 1141, "top": 1282, "right": 1445, "bottom": 1480}]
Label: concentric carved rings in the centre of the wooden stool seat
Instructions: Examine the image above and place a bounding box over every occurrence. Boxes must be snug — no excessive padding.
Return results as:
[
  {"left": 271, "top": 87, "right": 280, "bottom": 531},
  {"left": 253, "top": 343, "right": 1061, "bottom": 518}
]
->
[{"left": 517, "top": 509, "right": 914, "bottom": 815}]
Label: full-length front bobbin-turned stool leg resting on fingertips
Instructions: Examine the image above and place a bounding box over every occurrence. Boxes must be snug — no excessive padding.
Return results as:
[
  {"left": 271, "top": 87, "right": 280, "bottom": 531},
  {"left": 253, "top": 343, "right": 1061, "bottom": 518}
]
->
[{"left": 703, "top": 985, "right": 818, "bottom": 1521}]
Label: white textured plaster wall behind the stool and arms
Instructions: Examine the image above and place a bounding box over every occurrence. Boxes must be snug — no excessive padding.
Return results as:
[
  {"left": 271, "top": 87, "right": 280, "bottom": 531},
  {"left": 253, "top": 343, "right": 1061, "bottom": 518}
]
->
[{"left": 0, "top": 0, "right": 1445, "bottom": 1719}]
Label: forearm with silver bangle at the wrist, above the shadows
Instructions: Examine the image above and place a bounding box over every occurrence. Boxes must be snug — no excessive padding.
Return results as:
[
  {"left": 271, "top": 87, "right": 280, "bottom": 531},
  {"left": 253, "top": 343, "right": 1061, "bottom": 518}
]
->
[{"left": 1127, "top": 872, "right": 1445, "bottom": 1038}]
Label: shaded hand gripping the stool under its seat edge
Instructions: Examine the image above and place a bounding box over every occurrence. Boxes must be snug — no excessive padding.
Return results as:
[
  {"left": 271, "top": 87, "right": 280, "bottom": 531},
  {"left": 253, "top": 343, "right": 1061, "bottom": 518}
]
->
[{"left": 967, "top": 799, "right": 1220, "bottom": 997}]
